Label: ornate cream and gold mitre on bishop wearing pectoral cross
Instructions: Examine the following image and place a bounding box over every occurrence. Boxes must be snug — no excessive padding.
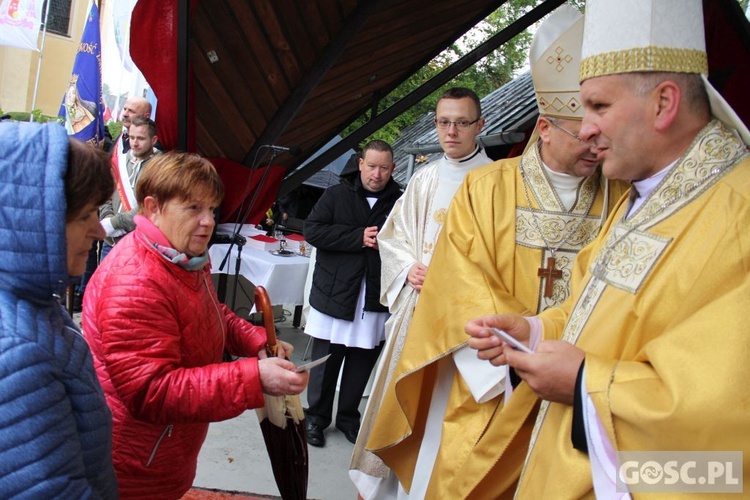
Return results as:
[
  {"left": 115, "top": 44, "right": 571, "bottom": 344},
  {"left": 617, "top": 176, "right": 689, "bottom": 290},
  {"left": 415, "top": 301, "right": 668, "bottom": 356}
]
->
[{"left": 529, "top": 4, "right": 583, "bottom": 120}]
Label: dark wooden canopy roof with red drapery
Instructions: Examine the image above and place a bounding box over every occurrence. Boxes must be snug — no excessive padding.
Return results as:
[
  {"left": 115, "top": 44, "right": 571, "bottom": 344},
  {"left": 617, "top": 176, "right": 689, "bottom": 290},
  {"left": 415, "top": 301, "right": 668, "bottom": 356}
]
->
[{"left": 131, "top": 0, "right": 750, "bottom": 209}]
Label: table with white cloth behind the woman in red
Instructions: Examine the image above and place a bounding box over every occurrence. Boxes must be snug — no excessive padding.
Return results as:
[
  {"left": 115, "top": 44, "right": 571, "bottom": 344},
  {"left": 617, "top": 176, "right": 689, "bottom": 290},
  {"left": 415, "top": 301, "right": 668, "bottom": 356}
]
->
[{"left": 209, "top": 227, "right": 310, "bottom": 326}]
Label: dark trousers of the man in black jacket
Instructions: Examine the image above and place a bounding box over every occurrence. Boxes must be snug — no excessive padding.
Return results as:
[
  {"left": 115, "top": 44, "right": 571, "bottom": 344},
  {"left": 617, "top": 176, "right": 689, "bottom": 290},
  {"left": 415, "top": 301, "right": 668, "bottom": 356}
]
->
[{"left": 307, "top": 338, "right": 383, "bottom": 430}]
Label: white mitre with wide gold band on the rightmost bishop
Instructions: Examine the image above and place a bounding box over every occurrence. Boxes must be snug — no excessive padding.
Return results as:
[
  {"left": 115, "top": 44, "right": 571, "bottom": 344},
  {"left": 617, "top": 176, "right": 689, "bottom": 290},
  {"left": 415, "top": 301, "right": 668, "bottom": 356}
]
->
[{"left": 580, "top": 0, "right": 750, "bottom": 144}]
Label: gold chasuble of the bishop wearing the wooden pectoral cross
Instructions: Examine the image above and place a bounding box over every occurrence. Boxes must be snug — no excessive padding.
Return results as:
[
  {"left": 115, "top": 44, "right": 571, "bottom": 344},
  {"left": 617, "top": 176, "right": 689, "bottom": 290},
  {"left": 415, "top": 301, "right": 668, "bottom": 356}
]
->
[{"left": 366, "top": 143, "right": 626, "bottom": 498}]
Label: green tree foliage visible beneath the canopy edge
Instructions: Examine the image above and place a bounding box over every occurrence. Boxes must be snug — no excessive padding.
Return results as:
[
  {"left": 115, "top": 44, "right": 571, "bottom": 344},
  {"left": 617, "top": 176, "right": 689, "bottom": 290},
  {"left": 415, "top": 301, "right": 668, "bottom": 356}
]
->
[{"left": 342, "top": 0, "right": 537, "bottom": 143}]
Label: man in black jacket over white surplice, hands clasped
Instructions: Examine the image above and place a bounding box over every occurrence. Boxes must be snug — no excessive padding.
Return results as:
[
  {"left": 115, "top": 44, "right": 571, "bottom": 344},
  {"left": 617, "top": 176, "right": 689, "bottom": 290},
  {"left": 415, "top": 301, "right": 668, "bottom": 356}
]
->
[{"left": 304, "top": 140, "right": 401, "bottom": 446}]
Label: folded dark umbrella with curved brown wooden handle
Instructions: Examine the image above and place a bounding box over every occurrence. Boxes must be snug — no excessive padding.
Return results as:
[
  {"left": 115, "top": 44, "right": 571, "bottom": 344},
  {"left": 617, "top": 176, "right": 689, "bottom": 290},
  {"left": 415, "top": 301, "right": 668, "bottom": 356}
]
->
[{"left": 255, "top": 286, "right": 308, "bottom": 500}]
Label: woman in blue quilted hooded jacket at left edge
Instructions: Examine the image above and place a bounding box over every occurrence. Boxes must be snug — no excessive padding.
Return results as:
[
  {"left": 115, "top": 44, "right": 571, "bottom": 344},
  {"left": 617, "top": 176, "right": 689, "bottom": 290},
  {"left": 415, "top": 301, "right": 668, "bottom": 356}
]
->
[{"left": 0, "top": 122, "right": 118, "bottom": 498}]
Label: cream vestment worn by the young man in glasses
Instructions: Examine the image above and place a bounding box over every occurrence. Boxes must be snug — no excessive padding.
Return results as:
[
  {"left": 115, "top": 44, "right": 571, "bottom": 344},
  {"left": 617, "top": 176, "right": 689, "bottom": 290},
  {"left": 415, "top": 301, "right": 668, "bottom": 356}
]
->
[{"left": 349, "top": 147, "right": 492, "bottom": 500}]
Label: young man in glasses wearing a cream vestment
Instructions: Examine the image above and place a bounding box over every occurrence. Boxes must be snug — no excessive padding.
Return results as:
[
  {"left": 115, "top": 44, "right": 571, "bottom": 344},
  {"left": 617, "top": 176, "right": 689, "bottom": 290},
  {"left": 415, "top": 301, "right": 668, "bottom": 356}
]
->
[{"left": 349, "top": 87, "right": 492, "bottom": 499}]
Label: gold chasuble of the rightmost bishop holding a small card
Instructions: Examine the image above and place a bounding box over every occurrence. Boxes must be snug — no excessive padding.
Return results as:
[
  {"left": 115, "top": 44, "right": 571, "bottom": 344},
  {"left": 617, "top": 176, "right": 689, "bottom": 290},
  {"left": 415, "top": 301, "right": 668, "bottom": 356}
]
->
[{"left": 513, "top": 121, "right": 750, "bottom": 498}]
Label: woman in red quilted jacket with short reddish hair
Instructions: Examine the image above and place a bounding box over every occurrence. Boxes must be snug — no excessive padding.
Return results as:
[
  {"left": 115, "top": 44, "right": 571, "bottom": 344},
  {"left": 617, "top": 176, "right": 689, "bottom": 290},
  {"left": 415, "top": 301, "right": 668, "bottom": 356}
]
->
[{"left": 83, "top": 153, "right": 308, "bottom": 499}]
